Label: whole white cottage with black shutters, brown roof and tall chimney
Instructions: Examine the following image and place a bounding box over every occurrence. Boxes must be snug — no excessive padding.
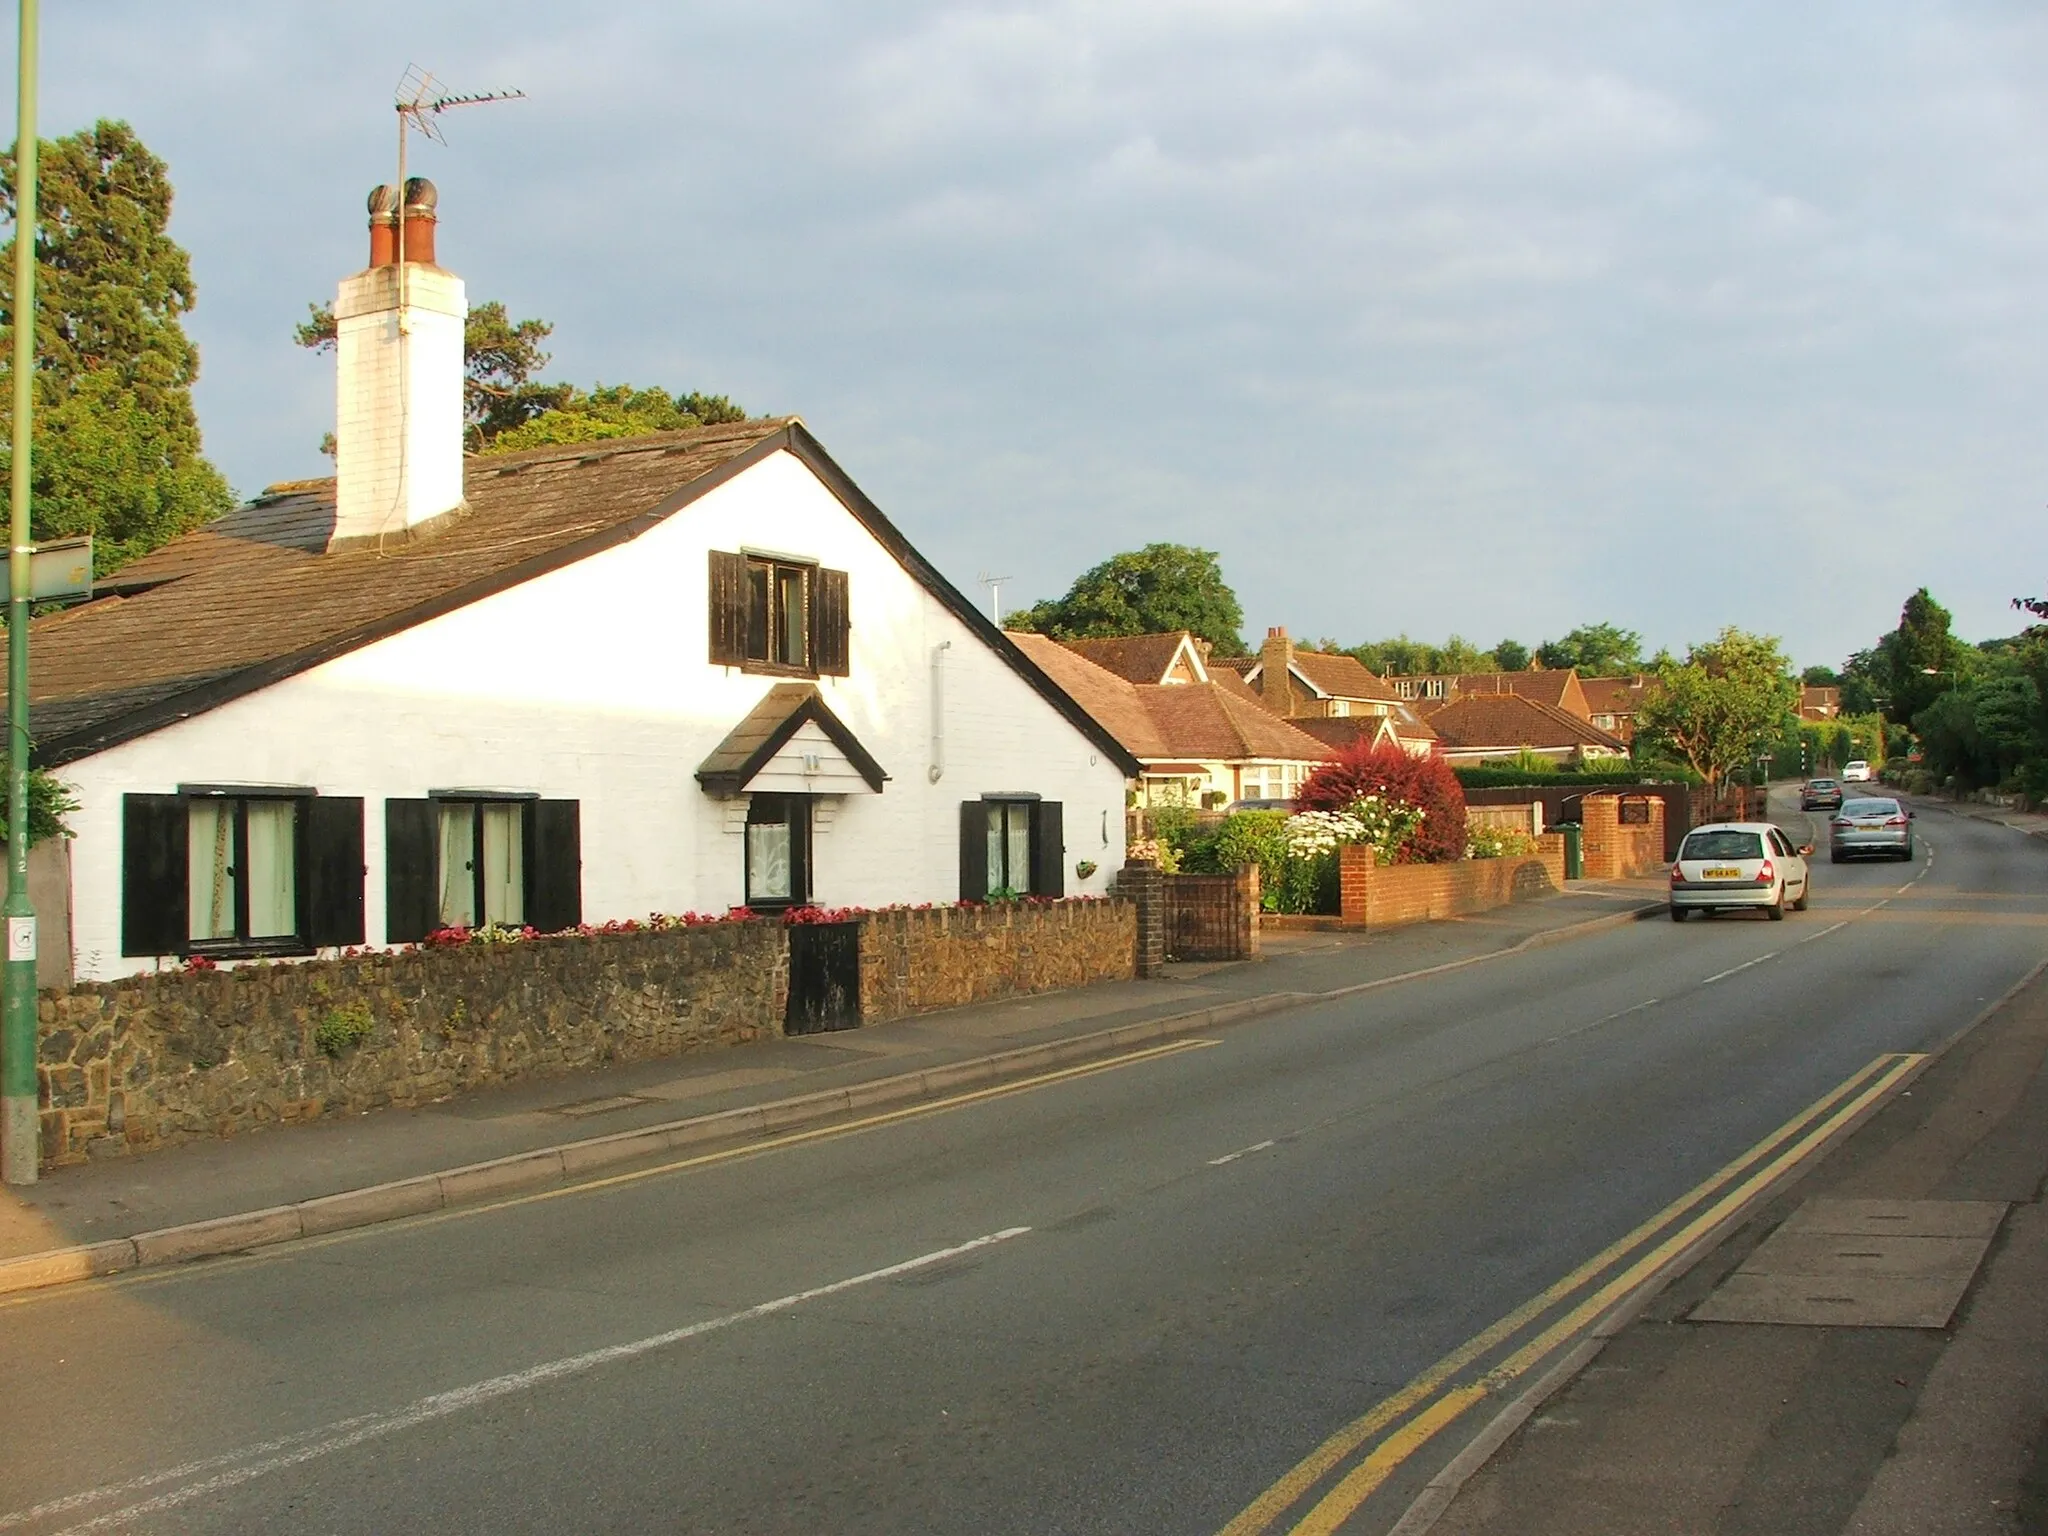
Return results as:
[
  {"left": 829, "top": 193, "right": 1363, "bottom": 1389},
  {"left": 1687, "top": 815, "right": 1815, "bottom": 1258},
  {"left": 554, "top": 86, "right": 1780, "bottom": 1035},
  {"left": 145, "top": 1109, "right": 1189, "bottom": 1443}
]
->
[{"left": 19, "top": 177, "right": 1139, "bottom": 979}]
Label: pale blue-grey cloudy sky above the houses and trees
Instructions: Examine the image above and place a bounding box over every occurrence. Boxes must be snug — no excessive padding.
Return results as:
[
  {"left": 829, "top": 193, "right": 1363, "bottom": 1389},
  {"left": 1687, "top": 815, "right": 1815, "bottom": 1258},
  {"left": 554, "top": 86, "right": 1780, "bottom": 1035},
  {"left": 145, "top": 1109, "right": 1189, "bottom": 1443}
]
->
[{"left": 8, "top": 0, "right": 2048, "bottom": 664}]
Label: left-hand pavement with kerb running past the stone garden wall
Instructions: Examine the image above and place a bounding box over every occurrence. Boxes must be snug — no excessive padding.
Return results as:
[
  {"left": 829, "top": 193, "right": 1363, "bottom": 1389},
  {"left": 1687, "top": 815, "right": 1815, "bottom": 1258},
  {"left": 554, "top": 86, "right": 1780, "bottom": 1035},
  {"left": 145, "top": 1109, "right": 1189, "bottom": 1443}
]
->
[{"left": 0, "top": 877, "right": 1665, "bottom": 1292}]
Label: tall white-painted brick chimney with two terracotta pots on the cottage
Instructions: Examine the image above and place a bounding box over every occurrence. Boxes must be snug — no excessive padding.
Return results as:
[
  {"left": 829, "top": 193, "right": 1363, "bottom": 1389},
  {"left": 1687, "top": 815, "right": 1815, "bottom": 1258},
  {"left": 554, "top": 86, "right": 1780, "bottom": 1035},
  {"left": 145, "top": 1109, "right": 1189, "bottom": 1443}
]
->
[{"left": 328, "top": 176, "right": 469, "bottom": 549}]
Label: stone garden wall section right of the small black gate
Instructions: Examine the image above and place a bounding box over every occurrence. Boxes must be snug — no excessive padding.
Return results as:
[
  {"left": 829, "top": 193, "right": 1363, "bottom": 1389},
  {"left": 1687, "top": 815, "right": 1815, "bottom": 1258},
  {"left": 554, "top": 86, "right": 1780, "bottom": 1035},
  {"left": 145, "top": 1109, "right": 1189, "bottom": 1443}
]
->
[{"left": 860, "top": 899, "right": 1137, "bottom": 1024}]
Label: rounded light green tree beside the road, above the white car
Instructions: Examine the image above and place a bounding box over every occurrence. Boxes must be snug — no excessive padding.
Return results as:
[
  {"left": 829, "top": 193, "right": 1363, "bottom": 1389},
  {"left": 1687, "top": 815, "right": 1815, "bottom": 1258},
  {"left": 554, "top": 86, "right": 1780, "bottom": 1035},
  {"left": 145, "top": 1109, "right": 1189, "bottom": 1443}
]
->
[{"left": 1636, "top": 629, "right": 1798, "bottom": 788}]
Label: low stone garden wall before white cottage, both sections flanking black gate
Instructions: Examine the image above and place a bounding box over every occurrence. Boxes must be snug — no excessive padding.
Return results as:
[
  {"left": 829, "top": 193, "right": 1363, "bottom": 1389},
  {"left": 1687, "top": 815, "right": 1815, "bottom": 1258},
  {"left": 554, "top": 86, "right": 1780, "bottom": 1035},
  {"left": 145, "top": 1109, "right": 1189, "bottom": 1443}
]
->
[{"left": 37, "top": 901, "right": 1137, "bottom": 1165}]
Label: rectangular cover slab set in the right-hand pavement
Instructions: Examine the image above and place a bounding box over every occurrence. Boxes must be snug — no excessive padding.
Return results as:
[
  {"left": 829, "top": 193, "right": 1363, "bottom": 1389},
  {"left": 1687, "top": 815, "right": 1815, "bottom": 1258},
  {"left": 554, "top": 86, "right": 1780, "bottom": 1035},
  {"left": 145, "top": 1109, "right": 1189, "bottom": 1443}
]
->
[{"left": 1692, "top": 1200, "right": 2005, "bottom": 1327}]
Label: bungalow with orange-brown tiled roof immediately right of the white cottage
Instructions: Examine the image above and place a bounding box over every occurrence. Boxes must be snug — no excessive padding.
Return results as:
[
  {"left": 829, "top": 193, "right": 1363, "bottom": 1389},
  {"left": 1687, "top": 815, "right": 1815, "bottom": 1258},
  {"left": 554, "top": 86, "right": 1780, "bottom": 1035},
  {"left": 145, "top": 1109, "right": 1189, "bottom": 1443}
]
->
[{"left": 1010, "top": 635, "right": 1335, "bottom": 809}]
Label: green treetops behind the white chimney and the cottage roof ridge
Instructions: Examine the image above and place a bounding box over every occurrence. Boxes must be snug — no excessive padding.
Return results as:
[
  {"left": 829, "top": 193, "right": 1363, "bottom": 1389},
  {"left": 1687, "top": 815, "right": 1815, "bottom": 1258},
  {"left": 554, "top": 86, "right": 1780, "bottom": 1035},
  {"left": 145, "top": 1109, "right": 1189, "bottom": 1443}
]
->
[{"left": 293, "top": 299, "right": 748, "bottom": 453}]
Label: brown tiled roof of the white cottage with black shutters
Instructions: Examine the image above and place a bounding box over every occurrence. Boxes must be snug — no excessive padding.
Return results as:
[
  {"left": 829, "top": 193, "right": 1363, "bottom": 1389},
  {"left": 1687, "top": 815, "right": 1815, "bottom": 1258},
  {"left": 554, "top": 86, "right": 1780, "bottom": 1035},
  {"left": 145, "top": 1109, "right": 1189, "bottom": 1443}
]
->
[{"left": 16, "top": 416, "right": 1128, "bottom": 766}]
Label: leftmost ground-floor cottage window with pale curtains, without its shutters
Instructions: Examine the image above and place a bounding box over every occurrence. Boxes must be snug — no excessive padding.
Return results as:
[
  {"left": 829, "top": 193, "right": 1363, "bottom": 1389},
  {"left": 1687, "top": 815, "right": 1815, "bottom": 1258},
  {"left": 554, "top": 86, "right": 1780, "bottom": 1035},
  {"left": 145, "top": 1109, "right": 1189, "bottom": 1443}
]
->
[{"left": 186, "top": 795, "right": 301, "bottom": 948}]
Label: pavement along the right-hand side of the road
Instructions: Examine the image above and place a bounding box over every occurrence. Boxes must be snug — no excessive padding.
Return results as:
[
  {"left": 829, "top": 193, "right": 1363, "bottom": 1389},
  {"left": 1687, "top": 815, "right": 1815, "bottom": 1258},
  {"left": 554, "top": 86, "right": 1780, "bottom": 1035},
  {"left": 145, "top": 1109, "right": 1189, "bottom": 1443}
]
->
[{"left": 1393, "top": 801, "right": 2048, "bottom": 1536}]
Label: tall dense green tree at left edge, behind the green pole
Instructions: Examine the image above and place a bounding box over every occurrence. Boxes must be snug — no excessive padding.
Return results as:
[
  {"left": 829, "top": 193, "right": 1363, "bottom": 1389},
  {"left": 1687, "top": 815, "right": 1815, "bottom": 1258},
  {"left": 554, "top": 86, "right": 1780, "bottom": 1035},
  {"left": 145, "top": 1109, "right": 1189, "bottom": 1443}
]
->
[{"left": 0, "top": 121, "right": 233, "bottom": 571}]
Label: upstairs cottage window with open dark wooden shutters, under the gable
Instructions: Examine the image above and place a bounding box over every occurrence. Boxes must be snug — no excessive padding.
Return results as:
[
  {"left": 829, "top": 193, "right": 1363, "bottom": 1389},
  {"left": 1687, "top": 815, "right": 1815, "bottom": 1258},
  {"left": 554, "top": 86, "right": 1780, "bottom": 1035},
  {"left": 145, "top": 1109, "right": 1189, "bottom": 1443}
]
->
[{"left": 709, "top": 551, "right": 850, "bottom": 678}]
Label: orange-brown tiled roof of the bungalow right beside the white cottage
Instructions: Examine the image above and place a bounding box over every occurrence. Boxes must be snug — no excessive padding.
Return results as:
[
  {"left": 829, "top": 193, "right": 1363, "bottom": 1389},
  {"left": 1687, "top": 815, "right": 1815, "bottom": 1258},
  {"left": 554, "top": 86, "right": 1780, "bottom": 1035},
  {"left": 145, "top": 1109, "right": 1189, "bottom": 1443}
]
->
[{"left": 1010, "top": 635, "right": 1329, "bottom": 762}]
